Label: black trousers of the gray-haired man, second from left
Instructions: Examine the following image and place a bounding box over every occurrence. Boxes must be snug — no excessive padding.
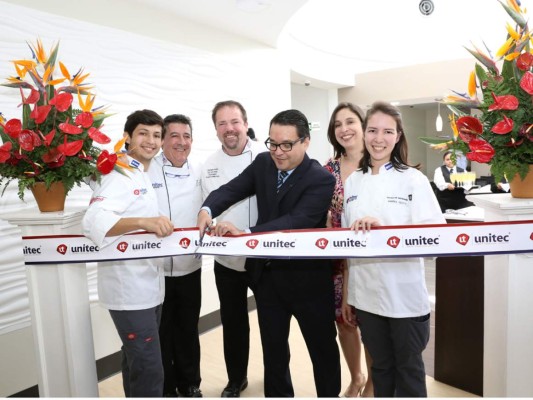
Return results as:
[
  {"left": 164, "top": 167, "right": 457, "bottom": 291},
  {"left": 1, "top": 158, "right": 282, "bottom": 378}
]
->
[{"left": 159, "top": 269, "right": 202, "bottom": 395}]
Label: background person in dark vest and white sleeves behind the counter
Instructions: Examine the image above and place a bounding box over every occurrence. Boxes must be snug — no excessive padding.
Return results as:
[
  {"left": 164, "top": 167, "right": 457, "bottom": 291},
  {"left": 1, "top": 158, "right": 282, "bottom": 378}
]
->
[{"left": 433, "top": 151, "right": 474, "bottom": 212}]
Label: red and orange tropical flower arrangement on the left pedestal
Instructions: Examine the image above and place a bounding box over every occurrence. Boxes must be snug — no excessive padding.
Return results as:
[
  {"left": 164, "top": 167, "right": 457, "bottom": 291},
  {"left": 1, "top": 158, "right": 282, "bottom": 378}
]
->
[{"left": 0, "top": 40, "right": 127, "bottom": 200}]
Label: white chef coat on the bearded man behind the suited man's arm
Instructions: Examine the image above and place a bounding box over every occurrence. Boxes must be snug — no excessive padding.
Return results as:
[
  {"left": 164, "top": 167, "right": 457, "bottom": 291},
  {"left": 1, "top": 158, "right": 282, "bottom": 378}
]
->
[{"left": 202, "top": 139, "right": 266, "bottom": 272}]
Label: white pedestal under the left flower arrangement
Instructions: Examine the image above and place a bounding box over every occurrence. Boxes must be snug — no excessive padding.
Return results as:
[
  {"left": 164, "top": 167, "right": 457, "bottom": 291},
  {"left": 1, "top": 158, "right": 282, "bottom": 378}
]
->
[{"left": 1, "top": 210, "right": 98, "bottom": 397}]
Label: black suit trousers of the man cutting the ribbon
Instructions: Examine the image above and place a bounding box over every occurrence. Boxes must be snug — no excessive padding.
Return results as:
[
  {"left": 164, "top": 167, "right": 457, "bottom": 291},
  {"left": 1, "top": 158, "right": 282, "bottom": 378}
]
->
[{"left": 255, "top": 266, "right": 341, "bottom": 397}]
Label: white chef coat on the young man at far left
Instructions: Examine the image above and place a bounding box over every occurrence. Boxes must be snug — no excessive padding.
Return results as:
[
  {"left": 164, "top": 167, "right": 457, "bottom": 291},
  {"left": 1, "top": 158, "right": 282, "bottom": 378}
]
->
[{"left": 83, "top": 157, "right": 165, "bottom": 310}]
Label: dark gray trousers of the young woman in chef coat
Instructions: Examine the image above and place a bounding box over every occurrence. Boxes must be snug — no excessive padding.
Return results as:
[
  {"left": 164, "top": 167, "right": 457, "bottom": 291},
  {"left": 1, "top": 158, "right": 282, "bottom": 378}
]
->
[{"left": 355, "top": 309, "right": 429, "bottom": 397}]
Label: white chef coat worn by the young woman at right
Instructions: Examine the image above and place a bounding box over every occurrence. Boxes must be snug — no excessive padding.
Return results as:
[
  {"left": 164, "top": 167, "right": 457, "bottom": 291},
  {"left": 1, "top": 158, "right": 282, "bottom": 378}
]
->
[{"left": 342, "top": 163, "right": 446, "bottom": 318}]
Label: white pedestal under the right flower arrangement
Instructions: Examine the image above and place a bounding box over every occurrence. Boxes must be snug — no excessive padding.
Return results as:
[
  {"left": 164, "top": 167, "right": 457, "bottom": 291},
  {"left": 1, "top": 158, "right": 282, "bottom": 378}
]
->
[{"left": 465, "top": 194, "right": 533, "bottom": 397}]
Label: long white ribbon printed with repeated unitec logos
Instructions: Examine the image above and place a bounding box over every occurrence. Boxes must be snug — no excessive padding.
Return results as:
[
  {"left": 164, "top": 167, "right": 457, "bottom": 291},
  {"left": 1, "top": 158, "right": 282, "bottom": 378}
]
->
[{"left": 23, "top": 221, "right": 533, "bottom": 264}]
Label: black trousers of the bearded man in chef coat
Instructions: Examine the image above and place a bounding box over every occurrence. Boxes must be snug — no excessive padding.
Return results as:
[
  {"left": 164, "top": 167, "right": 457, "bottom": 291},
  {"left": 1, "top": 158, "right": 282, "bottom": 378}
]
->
[{"left": 215, "top": 261, "right": 250, "bottom": 384}]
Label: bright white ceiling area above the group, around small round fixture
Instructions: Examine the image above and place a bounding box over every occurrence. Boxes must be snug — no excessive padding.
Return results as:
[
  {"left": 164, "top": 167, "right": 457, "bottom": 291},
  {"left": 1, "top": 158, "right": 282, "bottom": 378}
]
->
[{"left": 135, "top": 0, "right": 533, "bottom": 87}]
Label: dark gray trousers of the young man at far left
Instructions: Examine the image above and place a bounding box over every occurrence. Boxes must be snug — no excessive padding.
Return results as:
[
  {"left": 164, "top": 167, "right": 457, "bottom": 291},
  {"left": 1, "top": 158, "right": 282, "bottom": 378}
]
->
[{"left": 109, "top": 305, "right": 164, "bottom": 397}]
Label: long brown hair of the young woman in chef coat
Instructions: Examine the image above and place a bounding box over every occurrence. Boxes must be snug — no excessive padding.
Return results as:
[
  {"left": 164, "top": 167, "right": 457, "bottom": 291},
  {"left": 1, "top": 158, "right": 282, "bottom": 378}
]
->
[{"left": 361, "top": 101, "right": 420, "bottom": 173}]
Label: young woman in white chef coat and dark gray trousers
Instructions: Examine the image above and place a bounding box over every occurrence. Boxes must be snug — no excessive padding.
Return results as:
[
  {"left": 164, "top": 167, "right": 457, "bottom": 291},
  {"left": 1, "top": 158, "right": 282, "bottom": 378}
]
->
[{"left": 343, "top": 102, "right": 445, "bottom": 397}]
